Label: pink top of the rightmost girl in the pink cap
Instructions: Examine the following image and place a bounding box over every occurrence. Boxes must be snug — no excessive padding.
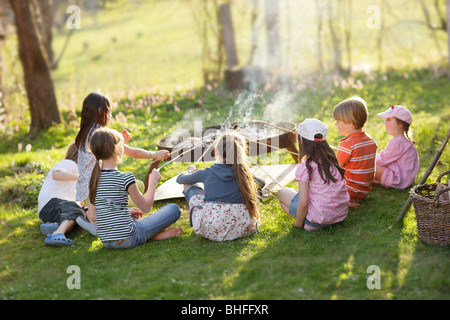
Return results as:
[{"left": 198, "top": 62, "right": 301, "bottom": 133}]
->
[{"left": 376, "top": 137, "right": 419, "bottom": 189}]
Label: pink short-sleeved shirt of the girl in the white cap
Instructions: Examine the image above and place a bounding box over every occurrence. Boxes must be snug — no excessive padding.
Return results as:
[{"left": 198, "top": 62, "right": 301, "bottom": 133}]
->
[{"left": 295, "top": 160, "right": 350, "bottom": 224}]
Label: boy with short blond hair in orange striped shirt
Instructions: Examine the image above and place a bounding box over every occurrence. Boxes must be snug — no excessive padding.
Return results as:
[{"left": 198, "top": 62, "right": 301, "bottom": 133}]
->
[{"left": 333, "top": 97, "right": 377, "bottom": 207}]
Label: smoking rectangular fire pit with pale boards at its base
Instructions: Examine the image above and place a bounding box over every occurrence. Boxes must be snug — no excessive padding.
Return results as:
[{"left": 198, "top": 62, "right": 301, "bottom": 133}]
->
[{"left": 148, "top": 120, "right": 299, "bottom": 195}]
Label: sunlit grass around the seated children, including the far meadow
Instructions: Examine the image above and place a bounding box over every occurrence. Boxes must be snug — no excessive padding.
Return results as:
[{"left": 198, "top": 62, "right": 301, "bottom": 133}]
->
[{"left": 0, "top": 1, "right": 450, "bottom": 300}]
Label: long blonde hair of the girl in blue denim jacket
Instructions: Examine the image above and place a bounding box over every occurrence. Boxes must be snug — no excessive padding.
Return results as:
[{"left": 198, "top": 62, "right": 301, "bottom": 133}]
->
[{"left": 215, "top": 131, "right": 259, "bottom": 220}]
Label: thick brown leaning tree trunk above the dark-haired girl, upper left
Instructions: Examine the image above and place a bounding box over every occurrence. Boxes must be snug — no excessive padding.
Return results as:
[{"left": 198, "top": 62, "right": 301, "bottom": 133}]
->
[{"left": 10, "top": 0, "right": 61, "bottom": 136}]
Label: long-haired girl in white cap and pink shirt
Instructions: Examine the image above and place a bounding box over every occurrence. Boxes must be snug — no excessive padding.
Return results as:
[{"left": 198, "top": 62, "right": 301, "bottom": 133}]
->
[{"left": 278, "top": 119, "right": 350, "bottom": 231}]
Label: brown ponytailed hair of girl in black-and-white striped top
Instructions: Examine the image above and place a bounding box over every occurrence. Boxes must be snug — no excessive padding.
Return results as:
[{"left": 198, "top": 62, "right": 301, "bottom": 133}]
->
[{"left": 89, "top": 127, "right": 123, "bottom": 203}]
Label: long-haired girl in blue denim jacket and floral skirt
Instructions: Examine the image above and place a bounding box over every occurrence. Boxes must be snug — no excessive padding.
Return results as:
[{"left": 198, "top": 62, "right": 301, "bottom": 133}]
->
[{"left": 177, "top": 131, "right": 259, "bottom": 241}]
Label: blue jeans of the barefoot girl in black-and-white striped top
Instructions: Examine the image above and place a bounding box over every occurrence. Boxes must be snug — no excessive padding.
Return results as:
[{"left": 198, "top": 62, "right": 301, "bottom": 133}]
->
[{"left": 102, "top": 203, "right": 181, "bottom": 249}]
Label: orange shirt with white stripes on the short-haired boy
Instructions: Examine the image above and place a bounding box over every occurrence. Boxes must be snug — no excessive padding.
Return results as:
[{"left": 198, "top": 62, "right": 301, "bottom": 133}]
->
[{"left": 336, "top": 131, "right": 377, "bottom": 201}]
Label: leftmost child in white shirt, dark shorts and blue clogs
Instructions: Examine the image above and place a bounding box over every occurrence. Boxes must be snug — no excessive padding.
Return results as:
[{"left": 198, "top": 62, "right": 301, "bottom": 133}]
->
[{"left": 38, "top": 143, "right": 84, "bottom": 246}]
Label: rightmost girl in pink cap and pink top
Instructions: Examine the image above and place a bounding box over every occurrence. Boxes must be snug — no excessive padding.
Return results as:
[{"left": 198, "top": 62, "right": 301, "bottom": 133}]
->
[{"left": 375, "top": 106, "right": 419, "bottom": 189}]
